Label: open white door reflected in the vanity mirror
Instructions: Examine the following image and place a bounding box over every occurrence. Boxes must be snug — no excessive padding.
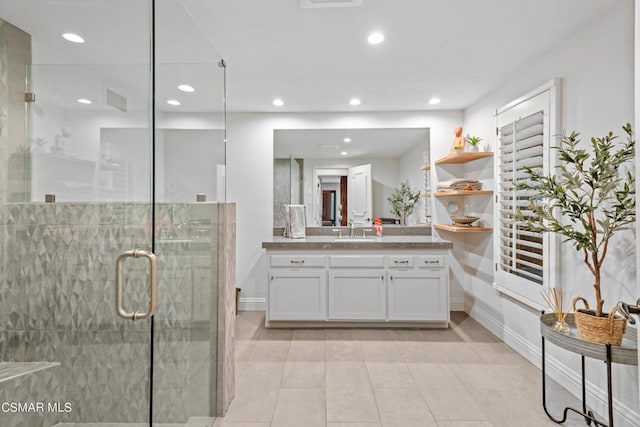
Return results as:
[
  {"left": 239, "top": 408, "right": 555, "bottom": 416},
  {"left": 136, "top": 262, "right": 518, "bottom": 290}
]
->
[{"left": 347, "top": 164, "right": 373, "bottom": 225}]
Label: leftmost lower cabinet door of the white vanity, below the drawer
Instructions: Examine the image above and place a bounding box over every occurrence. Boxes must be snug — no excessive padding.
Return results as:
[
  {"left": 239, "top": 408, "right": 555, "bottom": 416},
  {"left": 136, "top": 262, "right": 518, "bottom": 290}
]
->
[{"left": 268, "top": 269, "right": 327, "bottom": 320}]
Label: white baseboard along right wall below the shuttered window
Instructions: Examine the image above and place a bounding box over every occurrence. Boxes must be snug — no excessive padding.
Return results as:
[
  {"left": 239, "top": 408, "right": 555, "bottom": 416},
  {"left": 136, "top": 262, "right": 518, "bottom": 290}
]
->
[{"left": 465, "top": 304, "right": 640, "bottom": 426}]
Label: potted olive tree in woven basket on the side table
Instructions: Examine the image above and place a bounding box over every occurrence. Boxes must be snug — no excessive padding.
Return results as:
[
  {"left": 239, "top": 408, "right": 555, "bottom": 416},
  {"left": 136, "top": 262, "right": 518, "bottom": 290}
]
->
[{"left": 516, "top": 124, "right": 636, "bottom": 345}]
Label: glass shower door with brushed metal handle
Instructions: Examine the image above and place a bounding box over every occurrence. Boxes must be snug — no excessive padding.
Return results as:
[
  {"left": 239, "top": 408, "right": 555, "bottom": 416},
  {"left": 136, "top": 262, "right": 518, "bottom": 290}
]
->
[{"left": 0, "top": 0, "right": 158, "bottom": 427}]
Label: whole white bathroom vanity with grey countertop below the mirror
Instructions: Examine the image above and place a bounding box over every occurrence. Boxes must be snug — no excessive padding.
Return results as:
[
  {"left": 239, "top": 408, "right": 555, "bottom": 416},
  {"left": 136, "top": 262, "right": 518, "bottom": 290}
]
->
[{"left": 262, "top": 231, "right": 452, "bottom": 327}]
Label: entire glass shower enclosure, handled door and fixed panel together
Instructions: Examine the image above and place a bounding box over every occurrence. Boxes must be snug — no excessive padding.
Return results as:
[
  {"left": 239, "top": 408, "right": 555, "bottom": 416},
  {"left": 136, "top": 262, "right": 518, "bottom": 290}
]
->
[{"left": 0, "top": 0, "right": 225, "bottom": 427}]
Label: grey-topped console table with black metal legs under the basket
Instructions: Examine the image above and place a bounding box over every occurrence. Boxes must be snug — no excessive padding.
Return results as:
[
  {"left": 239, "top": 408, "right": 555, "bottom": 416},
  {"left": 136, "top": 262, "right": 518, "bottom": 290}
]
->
[{"left": 540, "top": 312, "right": 638, "bottom": 427}]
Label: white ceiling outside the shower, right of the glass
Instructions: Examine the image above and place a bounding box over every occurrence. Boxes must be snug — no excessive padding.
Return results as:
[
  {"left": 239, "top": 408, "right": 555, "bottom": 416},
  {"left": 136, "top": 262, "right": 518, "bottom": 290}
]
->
[{"left": 183, "top": 0, "right": 619, "bottom": 111}]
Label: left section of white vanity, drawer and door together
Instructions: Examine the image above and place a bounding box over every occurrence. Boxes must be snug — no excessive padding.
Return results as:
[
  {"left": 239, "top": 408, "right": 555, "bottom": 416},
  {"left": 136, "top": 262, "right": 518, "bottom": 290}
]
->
[{"left": 267, "top": 254, "right": 327, "bottom": 321}]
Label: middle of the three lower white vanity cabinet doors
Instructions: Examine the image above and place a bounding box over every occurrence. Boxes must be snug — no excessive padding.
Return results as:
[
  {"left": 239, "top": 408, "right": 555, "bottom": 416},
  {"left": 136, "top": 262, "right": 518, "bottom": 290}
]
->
[{"left": 329, "top": 269, "right": 387, "bottom": 320}]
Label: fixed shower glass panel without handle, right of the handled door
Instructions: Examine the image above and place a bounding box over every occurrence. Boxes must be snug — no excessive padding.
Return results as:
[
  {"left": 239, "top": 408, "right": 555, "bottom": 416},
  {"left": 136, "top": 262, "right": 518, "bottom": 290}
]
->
[{"left": 152, "top": 1, "right": 226, "bottom": 426}]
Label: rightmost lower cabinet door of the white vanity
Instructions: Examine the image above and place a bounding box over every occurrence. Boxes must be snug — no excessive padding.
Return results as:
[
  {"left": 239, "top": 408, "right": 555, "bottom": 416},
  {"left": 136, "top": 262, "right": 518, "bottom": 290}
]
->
[{"left": 388, "top": 269, "right": 449, "bottom": 321}]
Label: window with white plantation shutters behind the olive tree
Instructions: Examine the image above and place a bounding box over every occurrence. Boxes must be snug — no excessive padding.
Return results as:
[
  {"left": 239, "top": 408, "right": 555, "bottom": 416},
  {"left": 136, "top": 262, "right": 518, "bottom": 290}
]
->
[{"left": 494, "top": 80, "right": 559, "bottom": 309}]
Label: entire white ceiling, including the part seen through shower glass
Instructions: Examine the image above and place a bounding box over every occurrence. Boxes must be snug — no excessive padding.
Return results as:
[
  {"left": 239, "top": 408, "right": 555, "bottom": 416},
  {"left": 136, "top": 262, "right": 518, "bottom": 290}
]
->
[{"left": 0, "top": 0, "right": 625, "bottom": 112}]
